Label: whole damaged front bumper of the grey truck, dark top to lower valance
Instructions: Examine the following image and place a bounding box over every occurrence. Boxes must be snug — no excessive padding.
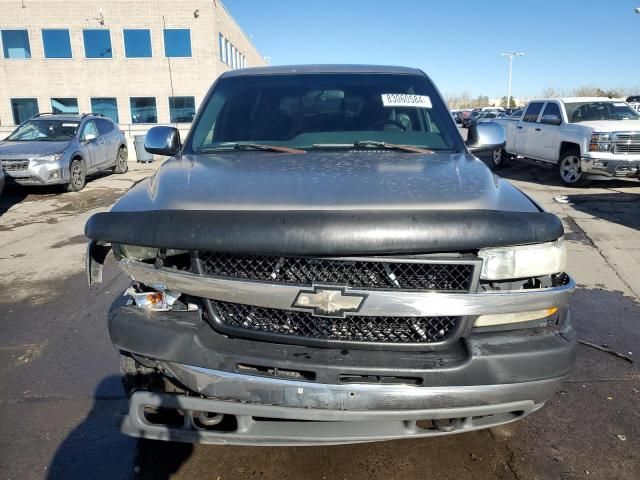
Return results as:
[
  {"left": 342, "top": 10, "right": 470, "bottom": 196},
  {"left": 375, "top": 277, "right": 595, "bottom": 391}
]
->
[{"left": 109, "top": 274, "right": 576, "bottom": 445}]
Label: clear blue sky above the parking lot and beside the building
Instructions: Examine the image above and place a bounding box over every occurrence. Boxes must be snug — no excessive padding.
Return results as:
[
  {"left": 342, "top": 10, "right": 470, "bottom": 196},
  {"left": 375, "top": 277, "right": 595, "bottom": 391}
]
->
[{"left": 223, "top": 0, "right": 640, "bottom": 98}]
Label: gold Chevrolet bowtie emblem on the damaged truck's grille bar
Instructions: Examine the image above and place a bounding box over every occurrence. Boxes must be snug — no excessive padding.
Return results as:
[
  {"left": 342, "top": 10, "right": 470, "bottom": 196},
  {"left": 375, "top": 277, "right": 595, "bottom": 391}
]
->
[{"left": 292, "top": 286, "right": 366, "bottom": 318}]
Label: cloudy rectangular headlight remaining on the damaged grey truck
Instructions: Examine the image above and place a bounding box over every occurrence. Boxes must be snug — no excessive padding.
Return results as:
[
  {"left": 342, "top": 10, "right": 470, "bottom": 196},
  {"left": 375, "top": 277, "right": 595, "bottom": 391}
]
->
[{"left": 478, "top": 239, "right": 567, "bottom": 280}]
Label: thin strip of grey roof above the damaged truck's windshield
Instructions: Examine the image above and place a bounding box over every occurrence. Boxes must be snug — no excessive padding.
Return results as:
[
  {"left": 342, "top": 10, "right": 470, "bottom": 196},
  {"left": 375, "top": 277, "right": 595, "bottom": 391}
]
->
[{"left": 220, "top": 64, "right": 424, "bottom": 77}]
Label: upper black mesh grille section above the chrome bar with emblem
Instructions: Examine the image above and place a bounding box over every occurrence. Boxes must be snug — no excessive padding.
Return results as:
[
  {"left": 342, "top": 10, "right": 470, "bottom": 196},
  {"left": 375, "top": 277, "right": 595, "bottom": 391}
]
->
[{"left": 200, "top": 252, "right": 475, "bottom": 292}]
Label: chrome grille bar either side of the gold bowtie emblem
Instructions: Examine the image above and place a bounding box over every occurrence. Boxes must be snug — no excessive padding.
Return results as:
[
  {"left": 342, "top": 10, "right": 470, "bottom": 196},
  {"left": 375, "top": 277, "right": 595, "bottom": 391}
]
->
[{"left": 119, "top": 259, "right": 575, "bottom": 317}]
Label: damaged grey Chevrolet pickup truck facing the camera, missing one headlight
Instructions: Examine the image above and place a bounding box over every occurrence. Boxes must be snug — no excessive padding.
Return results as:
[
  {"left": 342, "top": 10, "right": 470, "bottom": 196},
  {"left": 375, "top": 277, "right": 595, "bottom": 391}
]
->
[{"left": 86, "top": 66, "right": 576, "bottom": 445}]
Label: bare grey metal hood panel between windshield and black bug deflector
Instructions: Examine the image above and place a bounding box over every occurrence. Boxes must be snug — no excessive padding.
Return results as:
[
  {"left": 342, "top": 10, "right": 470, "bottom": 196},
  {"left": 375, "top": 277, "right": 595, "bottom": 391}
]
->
[{"left": 113, "top": 151, "right": 537, "bottom": 211}]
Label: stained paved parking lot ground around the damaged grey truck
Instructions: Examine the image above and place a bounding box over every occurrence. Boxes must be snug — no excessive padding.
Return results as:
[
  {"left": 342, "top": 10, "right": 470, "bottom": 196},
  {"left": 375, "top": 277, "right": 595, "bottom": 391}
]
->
[{"left": 0, "top": 156, "right": 640, "bottom": 480}]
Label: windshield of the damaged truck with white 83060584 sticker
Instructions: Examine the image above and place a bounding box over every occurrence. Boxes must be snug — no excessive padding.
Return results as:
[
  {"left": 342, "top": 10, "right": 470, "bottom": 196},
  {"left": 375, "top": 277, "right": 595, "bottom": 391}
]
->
[{"left": 187, "top": 74, "right": 464, "bottom": 151}]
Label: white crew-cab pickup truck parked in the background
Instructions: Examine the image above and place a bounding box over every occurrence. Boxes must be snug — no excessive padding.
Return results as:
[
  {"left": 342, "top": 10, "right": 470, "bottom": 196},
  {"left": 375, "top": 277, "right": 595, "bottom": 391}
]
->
[{"left": 493, "top": 97, "right": 640, "bottom": 187}]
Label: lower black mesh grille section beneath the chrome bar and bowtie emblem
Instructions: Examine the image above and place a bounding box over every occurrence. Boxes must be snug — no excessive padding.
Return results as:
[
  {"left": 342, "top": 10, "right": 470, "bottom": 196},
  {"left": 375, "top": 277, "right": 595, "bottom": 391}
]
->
[{"left": 211, "top": 301, "right": 461, "bottom": 344}]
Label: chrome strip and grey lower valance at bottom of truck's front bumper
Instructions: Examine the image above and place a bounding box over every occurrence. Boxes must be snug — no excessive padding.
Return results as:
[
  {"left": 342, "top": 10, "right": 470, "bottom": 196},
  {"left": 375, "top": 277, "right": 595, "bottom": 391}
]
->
[{"left": 122, "top": 363, "right": 562, "bottom": 445}]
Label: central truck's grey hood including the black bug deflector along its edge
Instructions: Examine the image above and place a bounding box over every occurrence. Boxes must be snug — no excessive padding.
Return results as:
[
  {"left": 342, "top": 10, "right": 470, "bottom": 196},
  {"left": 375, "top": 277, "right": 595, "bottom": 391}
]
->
[{"left": 85, "top": 151, "right": 563, "bottom": 255}]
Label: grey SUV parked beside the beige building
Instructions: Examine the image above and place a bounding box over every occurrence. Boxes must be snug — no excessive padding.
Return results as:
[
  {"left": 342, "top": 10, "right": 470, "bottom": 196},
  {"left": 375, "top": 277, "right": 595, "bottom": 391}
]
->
[{"left": 0, "top": 114, "right": 128, "bottom": 192}]
